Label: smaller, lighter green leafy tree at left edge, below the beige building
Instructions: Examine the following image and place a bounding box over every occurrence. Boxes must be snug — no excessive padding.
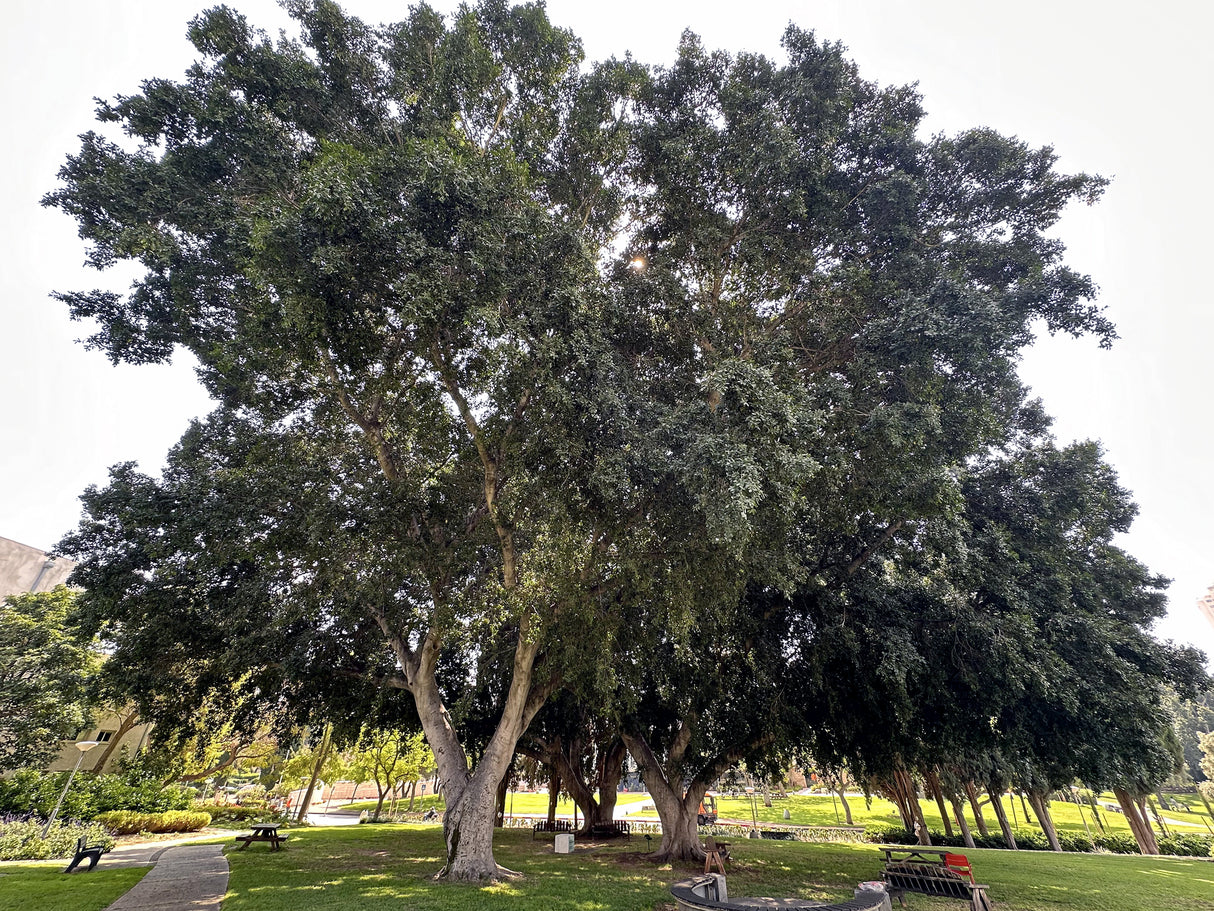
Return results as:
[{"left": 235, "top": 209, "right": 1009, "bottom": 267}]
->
[{"left": 0, "top": 585, "right": 101, "bottom": 771}]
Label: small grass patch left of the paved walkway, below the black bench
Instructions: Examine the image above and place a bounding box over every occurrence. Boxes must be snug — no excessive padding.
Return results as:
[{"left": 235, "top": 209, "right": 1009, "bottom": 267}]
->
[{"left": 0, "top": 860, "right": 151, "bottom": 911}]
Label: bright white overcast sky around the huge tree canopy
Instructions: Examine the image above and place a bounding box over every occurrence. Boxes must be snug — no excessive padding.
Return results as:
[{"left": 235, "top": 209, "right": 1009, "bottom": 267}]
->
[{"left": 0, "top": 0, "right": 1214, "bottom": 656}]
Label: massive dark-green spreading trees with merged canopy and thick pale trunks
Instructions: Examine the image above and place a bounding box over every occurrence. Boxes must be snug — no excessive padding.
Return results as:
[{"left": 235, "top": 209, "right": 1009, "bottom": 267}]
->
[{"left": 46, "top": 0, "right": 1202, "bottom": 879}]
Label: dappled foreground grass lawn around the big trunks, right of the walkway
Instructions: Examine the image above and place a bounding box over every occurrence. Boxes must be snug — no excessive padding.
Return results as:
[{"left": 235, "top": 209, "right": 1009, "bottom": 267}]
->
[{"left": 223, "top": 825, "right": 1214, "bottom": 911}]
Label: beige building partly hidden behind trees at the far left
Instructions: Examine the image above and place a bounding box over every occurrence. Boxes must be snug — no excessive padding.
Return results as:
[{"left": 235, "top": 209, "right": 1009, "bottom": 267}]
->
[{"left": 0, "top": 538, "right": 152, "bottom": 771}]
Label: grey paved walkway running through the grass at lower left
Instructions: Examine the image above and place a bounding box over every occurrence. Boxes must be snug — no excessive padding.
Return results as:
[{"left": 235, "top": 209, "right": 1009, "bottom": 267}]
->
[{"left": 102, "top": 844, "right": 228, "bottom": 911}]
